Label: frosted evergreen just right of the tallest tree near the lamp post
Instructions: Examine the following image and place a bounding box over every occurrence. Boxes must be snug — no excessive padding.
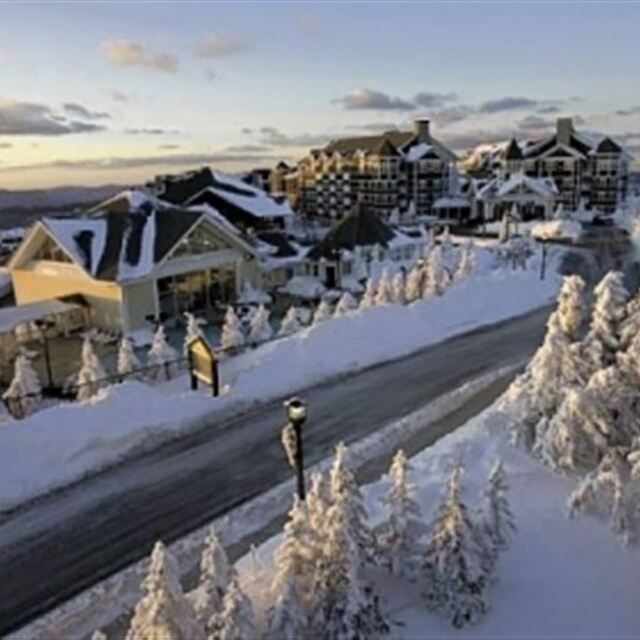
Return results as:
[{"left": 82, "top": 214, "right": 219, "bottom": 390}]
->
[{"left": 378, "top": 450, "right": 427, "bottom": 578}]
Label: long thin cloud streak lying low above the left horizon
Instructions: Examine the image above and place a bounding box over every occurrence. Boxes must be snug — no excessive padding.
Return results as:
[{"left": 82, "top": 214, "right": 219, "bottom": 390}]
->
[{"left": 0, "top": 152, "right": 291, "bottom": 173}]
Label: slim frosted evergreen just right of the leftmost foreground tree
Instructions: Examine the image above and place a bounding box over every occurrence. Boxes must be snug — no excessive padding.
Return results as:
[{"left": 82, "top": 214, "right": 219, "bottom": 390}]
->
[{"left": 192, "top": 526, "right": 235, "bottom": 628}]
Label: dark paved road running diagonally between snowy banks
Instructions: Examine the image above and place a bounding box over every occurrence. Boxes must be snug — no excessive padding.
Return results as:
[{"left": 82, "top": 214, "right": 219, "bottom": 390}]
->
[{"left": 0, "top": 308, "right": 549, "bottom": 635}]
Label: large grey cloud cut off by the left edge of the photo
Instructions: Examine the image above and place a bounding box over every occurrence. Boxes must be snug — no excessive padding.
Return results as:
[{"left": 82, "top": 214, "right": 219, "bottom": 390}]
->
[{"left": 0, "top": 100, "right": 105, "bottom": 136}]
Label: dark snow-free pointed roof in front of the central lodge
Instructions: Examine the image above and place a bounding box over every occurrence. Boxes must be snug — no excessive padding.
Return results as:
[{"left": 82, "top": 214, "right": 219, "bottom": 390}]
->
[{"left": 307, "top": 204, "right": 395, "bottom": 260}]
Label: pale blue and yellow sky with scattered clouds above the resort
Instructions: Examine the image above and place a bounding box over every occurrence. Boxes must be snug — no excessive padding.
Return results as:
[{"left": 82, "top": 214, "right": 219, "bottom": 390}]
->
[{"left": 0, "top": 0, "right": 640, "bottom": 189}]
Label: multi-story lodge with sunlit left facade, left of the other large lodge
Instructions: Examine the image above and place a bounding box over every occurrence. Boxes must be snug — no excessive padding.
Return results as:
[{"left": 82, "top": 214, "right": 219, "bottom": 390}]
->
[{"left": 296, "top": 119, "right": 457, "bottom": 219}]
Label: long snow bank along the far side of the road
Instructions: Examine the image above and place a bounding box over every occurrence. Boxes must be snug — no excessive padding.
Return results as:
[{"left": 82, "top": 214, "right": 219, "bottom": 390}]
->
[{"left": 0, "top": 270, "right": 559, "bottom": 510}]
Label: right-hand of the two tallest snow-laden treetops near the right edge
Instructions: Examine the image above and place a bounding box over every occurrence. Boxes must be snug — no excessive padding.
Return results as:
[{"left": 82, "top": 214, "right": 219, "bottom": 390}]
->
[{"left": 584, "top": 271, "right": 629, "bottom": 371}]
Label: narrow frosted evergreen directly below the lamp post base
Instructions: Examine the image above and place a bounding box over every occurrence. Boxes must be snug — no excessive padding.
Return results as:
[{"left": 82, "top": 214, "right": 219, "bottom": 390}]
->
[{"left": 268, "top": 496, "right": 313, "bottom": 640}]
